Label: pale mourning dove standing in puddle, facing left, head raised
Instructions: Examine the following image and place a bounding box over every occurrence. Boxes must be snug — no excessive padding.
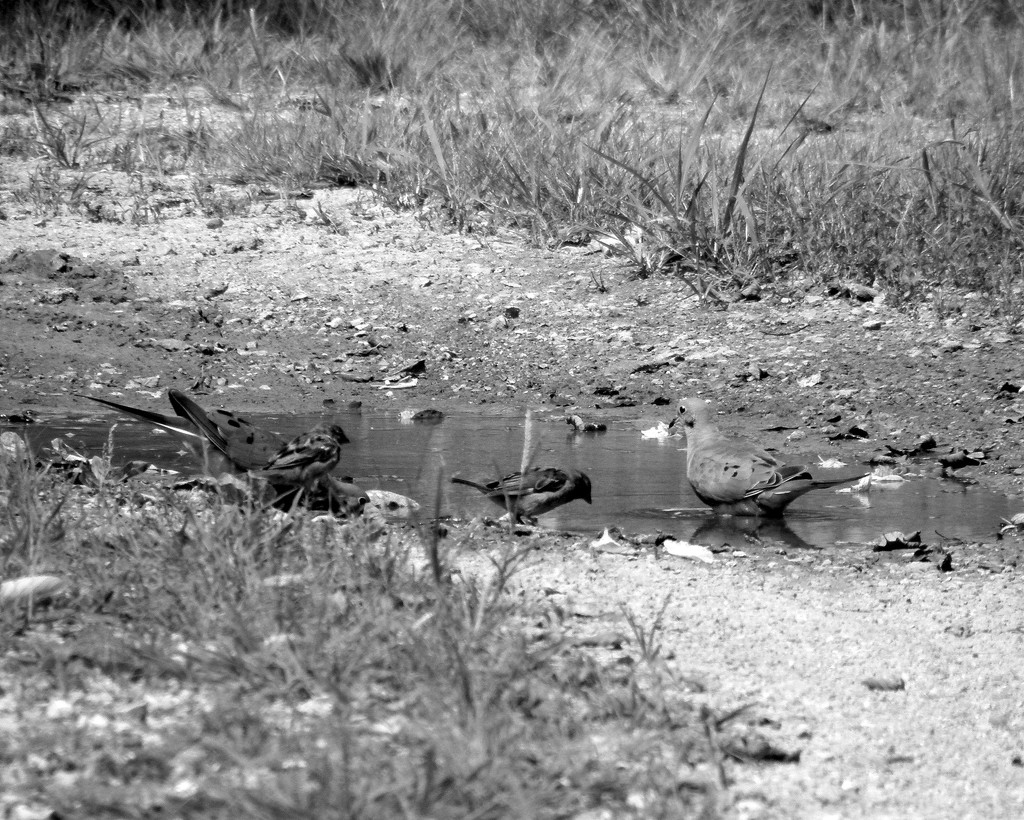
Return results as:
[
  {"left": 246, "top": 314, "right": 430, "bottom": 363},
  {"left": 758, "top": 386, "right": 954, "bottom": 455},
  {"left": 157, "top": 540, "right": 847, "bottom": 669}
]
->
[{"left": 672, "top": 398, "right": 863, "bottom": 516}]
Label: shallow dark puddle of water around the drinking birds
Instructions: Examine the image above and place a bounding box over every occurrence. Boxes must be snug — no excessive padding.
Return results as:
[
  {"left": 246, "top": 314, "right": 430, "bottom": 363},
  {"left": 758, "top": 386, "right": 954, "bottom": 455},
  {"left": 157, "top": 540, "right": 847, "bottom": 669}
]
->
[{"left": 6, "top": 412, "right": 1021, "bottom": 548}]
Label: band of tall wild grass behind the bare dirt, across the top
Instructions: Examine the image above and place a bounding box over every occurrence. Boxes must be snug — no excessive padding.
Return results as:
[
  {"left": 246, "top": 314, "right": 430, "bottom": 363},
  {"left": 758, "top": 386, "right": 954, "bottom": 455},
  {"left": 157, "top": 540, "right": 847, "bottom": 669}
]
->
[{"left": 0, "top": 0, "right": 1024, "bottom": 327}]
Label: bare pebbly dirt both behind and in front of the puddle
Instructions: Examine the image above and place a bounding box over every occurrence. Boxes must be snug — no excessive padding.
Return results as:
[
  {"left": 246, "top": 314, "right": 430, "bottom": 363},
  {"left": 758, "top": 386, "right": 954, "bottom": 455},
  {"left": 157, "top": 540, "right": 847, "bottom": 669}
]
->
[{"left": 0, "top": 169, "right": 1024, "bottom": 818}]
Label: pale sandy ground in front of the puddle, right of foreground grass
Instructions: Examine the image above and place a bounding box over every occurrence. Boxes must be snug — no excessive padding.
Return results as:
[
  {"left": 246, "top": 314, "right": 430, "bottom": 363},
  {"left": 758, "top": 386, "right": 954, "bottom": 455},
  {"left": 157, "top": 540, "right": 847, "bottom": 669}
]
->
[{"left": 497, "top": 550, "right": 1024, "bottom": 818}]
